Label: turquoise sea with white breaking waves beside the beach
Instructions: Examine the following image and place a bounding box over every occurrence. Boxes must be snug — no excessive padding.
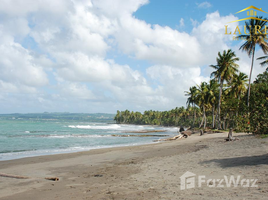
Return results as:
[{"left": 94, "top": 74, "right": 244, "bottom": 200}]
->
[{"left": 0, "top": 120, "right": 180, "bottom": 160}]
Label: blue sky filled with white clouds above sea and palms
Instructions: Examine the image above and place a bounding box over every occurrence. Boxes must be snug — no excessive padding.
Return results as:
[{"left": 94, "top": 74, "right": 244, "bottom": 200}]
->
[{"left": 0, "top": 0, "right": 268, "bottom": 113}]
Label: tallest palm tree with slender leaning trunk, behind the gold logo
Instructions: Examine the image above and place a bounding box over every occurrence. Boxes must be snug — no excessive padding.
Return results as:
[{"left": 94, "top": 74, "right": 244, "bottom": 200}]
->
[{"left": 237, "top": 17, "right": 268, "bottom": 107}]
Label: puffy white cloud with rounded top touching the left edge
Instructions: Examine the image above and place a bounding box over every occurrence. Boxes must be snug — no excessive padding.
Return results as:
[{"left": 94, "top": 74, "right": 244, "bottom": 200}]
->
[{"left": 0, "top": 34, "right": 48, "bottom": 92}]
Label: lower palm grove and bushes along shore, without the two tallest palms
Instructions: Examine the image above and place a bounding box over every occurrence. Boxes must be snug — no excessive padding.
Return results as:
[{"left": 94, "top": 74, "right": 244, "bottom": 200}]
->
[{"left": 114, "top": 65, "right": 268, "bottom": 134}]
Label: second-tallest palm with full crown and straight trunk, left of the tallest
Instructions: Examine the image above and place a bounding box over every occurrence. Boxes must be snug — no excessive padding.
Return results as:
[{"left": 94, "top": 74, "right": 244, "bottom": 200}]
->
[{"left": 210, "top": 49, "right": 239, "bottom": 129}]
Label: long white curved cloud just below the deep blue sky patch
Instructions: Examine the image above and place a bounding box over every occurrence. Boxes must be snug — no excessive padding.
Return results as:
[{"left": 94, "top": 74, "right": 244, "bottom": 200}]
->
[{"left": 115, "top": 11, "right": 237, "bottom": 68}]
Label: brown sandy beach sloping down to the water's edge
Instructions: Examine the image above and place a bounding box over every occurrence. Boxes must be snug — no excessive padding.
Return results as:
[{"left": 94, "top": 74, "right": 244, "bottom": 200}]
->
[{"left": 0, "top": 133, "right": 268, "bottom": 200}]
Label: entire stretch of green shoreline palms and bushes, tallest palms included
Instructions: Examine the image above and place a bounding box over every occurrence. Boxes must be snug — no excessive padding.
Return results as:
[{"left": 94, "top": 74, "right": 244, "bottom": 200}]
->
[{"left": 114, "top": 17, "right": 268, "bottom": 134}]
